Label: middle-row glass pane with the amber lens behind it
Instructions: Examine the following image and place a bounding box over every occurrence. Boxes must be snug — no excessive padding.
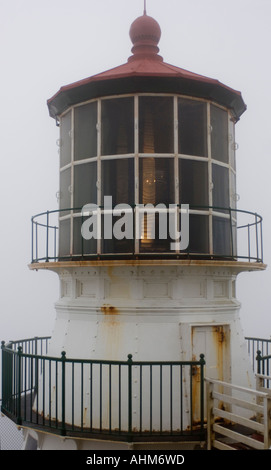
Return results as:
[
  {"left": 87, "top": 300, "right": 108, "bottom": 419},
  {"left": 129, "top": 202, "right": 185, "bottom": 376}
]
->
[{"left": 139, "top": 158, "right": 175, "bottom": 205}]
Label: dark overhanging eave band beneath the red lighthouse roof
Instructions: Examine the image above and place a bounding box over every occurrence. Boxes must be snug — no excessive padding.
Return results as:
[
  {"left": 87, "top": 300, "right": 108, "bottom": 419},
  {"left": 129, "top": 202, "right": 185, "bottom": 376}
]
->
[{"left": 47, "top": 71, "right": 246, "bottom": 120}]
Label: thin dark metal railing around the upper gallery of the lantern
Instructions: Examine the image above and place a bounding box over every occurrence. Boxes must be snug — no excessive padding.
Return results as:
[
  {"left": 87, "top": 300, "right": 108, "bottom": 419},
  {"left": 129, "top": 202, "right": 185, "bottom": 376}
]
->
[{"left": 31, "top": 205, "right": 263, "bottom": 263}]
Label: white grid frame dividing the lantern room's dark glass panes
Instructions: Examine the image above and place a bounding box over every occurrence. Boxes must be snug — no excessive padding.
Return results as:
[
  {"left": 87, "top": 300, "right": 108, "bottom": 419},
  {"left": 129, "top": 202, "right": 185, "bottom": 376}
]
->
[{"left": 59, "top": 93, "right": 236, "bottom": 255}]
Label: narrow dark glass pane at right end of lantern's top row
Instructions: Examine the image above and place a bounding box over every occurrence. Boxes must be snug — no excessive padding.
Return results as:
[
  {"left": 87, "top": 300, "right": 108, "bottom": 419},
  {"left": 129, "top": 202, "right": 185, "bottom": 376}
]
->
[{"left": 211, "top": 105, "right": 229, "bottom": 163}]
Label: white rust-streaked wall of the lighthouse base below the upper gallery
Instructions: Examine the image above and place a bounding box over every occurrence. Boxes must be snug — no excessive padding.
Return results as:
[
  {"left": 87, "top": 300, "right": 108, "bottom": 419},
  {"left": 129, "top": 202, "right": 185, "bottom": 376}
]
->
[{"left": 31, "top": 263, "right": 260, "bottom": 440}]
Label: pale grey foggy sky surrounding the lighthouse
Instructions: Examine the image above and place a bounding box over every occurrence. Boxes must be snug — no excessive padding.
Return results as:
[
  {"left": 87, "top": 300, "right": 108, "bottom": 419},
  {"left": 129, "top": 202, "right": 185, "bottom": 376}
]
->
[{"left": 0, "top": 0, "right": 271, "bottom": 346}]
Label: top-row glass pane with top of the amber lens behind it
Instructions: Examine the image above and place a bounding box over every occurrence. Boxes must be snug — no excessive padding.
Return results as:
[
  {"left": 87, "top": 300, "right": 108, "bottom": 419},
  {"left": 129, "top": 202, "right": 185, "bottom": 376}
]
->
[{"left": 139, "top": 96, "right": 174, "bottom": 153}]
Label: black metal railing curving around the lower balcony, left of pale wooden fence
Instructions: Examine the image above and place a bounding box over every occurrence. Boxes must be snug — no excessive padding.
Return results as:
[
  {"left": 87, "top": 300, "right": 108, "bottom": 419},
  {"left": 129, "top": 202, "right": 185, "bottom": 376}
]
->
[{"left": 2, "top": 338, "right": 205, "bottom": 440}]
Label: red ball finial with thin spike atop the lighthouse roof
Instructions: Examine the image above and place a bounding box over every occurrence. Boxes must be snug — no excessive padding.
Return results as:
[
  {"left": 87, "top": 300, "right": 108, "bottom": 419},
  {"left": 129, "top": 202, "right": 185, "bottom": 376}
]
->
[{"left": 129, "top": 1, "right": 163, "bottom": 60}]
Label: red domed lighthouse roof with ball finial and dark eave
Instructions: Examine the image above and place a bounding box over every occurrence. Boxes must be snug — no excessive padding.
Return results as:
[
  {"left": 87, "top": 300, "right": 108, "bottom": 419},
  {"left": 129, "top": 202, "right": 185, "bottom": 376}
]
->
[{"left": 47, "top": 12, "right": 246, "bottom": 120}]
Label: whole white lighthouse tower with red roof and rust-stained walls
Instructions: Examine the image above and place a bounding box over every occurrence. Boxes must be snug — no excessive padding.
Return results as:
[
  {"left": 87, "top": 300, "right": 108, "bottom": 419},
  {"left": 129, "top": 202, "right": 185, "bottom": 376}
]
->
[{"left": 3, "top": 7, "right": 264, "bottom": 450}]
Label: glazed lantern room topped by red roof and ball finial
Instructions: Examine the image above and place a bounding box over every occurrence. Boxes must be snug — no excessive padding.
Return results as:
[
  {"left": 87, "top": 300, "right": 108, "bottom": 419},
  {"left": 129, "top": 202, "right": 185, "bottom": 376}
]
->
[{"left": 44, "top": 13, "right": 251, "bottom": 260}]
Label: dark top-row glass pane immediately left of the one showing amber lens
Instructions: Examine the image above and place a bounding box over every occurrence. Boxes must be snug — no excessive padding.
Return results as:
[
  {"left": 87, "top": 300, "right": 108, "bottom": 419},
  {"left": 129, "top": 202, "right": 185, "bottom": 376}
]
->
[{"left": 102, "top": 98, "right": 134, "bottom": 155}]
